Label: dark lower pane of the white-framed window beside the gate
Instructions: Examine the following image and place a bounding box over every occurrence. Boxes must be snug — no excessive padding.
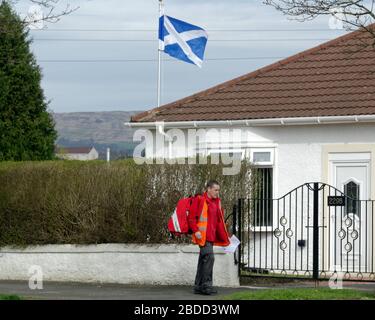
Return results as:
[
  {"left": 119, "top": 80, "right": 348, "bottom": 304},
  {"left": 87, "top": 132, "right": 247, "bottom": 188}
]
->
[{"left": 252, "top": 168, "right": 273, "bottom": 227}]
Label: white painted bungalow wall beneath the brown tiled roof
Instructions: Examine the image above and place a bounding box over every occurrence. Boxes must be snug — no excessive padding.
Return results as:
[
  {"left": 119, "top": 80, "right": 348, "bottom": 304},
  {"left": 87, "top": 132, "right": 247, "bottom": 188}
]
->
[{"left": 140, "top": 123, "right": 375, "bottom": 276}]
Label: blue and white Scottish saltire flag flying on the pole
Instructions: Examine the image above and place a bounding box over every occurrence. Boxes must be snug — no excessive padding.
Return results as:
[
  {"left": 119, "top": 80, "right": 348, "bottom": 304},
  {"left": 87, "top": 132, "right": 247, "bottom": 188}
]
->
[{"left": 159, "top": 15, "right": 208, "bottom": 68}]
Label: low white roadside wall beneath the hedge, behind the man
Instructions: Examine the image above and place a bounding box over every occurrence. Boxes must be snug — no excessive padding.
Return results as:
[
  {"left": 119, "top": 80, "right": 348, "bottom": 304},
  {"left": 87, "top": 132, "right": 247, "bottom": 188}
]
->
[{"left": 0, "top": 244, "right": 239, "bottom": 287}]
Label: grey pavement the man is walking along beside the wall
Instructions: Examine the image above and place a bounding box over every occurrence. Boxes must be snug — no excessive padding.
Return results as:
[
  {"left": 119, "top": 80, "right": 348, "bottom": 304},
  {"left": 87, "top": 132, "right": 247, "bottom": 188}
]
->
[{"left": 0, "top": 280, "right": 375, "bottom": 300}]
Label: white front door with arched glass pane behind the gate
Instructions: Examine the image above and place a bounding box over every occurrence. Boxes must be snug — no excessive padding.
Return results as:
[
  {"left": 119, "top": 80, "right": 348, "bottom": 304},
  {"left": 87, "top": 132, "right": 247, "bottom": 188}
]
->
[{"left": 329, "top": 153, "right": 372, "bottom": 273}]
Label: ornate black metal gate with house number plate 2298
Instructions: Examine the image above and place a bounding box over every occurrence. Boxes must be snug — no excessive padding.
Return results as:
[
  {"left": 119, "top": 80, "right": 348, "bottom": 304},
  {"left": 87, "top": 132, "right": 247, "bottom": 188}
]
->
[{"left": 233, "top": 182, "right": 375, "bottom": 281}]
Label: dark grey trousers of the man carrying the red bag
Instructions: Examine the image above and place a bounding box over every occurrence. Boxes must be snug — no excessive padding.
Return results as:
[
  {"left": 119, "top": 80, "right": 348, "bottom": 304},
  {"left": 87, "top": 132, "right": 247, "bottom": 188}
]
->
[{"left": 194, "top": 241, "right": 215, "bottom": 290}]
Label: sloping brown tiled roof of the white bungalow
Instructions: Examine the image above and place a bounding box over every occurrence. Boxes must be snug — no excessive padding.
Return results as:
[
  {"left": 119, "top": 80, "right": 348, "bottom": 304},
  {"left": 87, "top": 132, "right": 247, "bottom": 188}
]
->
[{"left": 131, "top": 25, "right": 375, "bottom": 122}]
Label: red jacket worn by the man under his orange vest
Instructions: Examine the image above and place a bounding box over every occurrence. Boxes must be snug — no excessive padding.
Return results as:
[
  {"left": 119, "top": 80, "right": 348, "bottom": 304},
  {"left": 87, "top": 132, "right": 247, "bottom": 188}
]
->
[{"left": 188, "top": 192, "right": 229, "bottom": 242}]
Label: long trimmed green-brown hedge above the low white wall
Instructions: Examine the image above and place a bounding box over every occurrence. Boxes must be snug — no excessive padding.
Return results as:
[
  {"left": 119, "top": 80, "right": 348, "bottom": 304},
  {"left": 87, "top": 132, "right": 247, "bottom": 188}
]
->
[{"left": 0, "top": 159, "right": 251, "bottom": 246}]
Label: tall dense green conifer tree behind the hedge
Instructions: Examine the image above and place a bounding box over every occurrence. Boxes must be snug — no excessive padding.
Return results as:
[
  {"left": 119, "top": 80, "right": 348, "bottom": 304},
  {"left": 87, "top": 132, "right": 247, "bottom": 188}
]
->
[{"left": 0, "top": 1, "right": 57, "bottom": 160}]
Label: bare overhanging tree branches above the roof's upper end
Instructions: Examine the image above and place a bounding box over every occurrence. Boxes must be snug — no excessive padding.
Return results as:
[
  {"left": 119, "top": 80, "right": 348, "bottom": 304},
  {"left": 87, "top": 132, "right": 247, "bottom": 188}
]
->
[{"left": 264, "top": 0, "right": 375, "bottom": 44}]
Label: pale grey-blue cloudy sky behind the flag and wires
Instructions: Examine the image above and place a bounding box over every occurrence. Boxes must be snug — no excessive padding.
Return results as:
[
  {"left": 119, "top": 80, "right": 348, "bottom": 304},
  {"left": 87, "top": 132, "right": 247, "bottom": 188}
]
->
[{"left": 17, "top": 0, "right": 346, "bottom": 113}]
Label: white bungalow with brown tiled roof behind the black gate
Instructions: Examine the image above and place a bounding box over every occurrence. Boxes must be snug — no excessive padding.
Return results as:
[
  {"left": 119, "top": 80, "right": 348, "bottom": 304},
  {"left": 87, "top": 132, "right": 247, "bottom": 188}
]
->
[{"left": 128, "top": 25, "right": 375, "bottom": 279}]
